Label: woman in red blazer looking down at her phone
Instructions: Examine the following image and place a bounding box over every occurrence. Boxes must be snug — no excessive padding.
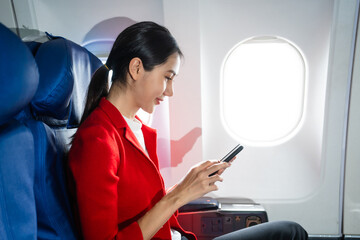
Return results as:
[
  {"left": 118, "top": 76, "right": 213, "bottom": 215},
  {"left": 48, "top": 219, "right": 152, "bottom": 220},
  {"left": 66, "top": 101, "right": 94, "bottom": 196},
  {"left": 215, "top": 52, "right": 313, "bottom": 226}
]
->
[{"left": 69, "top": 22, "right": 305, "bottom": 240}]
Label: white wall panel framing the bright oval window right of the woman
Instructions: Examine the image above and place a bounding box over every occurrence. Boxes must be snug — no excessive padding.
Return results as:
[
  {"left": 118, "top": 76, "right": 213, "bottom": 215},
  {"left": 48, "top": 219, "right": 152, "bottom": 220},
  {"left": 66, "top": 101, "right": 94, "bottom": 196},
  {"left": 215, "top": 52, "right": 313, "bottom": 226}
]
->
[{"left": 174, "top": 1, "right": 357, "bottom": 236}]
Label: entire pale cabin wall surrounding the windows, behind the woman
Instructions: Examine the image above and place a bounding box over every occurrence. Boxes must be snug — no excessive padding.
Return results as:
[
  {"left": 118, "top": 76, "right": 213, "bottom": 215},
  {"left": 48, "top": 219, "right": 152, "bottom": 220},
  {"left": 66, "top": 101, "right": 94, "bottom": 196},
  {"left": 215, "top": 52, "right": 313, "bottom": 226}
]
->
[{"left": 0, "top": 0, "right": 360, "bottom": 236}]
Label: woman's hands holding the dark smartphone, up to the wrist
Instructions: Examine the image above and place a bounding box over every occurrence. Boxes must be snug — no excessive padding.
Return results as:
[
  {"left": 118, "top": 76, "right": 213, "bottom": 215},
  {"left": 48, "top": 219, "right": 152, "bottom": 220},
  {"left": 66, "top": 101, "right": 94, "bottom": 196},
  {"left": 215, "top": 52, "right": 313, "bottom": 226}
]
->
[{"left": 167, "top": 160, "right": 230, "bottom": 207}]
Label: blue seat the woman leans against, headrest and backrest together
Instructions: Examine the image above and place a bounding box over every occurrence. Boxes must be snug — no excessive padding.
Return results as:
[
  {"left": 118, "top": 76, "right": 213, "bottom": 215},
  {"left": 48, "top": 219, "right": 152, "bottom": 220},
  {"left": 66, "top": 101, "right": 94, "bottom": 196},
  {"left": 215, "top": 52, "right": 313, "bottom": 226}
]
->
[{"left": 27, "top": 33, "right": 102, "bottom": 240}]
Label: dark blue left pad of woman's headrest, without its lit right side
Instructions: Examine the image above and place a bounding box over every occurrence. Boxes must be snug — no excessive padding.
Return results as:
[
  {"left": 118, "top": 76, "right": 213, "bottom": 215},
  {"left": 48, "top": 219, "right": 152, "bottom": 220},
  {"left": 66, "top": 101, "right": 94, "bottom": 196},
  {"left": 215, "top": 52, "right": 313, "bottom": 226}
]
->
[{"left": 31, "top": 39, "right": 74, "bottom": 120}]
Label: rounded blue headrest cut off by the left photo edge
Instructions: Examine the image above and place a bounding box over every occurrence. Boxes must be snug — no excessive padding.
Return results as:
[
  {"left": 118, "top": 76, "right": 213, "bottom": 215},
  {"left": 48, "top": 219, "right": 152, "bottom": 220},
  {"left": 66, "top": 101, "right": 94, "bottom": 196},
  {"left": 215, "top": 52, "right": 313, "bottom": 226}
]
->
[{"left": 0, "top": 23, "right": 39, "bottom": 125}]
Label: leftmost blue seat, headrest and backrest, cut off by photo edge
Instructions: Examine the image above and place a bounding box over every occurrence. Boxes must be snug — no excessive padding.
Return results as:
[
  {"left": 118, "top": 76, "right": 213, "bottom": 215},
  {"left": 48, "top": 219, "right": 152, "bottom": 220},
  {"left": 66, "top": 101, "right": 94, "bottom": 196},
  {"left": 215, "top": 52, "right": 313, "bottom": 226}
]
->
[{"left": 0, "top": 23, "right": 39, "bottom": 240}]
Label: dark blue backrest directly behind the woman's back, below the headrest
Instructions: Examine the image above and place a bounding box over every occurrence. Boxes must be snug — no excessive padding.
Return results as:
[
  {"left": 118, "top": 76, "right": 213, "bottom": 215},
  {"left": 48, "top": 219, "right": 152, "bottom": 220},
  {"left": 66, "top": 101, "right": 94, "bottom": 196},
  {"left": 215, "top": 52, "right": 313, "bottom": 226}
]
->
[{"left": 26, "top": 120, "right": 77, "bottom": 240}]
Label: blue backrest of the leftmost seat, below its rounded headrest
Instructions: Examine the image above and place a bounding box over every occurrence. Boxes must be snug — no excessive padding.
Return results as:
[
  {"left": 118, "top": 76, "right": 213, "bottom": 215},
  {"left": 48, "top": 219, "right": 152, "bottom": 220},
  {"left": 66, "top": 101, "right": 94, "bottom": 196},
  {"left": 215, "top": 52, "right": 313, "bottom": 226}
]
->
[{"left": 0, "top": 121, "right": 37, "bottom": 239}]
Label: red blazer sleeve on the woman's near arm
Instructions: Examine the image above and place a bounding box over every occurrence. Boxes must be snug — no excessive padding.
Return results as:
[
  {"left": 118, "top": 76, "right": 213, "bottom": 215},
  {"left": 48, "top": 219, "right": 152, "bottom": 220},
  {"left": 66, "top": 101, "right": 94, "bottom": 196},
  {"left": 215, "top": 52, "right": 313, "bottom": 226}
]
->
[{"left": 69, "top": 126, "right": 143, "bottom": 240}]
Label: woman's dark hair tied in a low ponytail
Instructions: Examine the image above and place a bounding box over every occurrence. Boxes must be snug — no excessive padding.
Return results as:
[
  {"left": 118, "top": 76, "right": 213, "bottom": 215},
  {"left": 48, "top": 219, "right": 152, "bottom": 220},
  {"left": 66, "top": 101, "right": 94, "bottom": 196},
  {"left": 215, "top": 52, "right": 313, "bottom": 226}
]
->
[{"left": 80, "top": 22, "right": 182, "bottom": 124}]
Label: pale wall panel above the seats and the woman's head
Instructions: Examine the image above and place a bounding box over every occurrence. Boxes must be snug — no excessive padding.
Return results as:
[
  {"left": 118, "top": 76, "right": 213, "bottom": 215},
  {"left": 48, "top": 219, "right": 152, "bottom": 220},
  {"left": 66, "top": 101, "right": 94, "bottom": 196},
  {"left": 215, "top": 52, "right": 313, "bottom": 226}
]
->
[{"left": 29, "top": 0, "right": 164, "bottom": 45}]
